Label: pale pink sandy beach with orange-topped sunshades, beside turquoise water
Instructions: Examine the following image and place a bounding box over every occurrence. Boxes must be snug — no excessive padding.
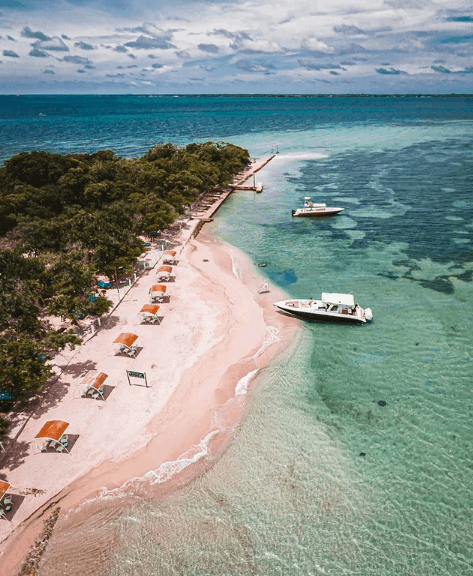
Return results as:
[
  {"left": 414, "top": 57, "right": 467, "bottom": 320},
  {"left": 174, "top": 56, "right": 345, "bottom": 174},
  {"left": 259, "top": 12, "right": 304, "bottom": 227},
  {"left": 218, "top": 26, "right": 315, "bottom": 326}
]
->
[{"left": 0, "top": 162, "right": 298, "bottom": 575}]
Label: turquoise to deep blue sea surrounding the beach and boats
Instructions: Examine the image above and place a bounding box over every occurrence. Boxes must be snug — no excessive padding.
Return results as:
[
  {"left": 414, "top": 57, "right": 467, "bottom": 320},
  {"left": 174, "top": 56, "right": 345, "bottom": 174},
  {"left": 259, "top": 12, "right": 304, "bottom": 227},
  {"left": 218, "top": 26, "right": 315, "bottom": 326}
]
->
[{"left": 0, "top": 96, "right": 473, "bottom": 576}]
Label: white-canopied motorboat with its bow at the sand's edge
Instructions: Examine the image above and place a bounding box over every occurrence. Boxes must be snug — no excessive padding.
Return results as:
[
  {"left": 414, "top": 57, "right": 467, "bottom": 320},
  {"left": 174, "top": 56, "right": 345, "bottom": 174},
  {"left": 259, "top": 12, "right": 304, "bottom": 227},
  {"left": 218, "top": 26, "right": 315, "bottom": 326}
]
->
[{"left": 274, "top": 292, "right": 373, "bottom": 324}]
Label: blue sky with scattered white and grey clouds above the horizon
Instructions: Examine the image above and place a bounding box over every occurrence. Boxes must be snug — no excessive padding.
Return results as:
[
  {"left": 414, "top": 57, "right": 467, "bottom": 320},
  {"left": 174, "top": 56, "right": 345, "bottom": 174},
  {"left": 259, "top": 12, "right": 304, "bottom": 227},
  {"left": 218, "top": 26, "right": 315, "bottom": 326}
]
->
[{"left": 0, "top": 0, "right": 473, "bottom": 94}]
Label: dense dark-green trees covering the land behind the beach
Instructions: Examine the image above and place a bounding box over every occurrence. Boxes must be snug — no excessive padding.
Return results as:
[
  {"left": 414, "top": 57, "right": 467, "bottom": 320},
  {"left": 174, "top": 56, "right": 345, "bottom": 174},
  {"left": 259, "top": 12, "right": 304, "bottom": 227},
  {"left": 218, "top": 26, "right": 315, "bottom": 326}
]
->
[{"left": 0, "top": 142, "right": 250, "bottom": 397}]
